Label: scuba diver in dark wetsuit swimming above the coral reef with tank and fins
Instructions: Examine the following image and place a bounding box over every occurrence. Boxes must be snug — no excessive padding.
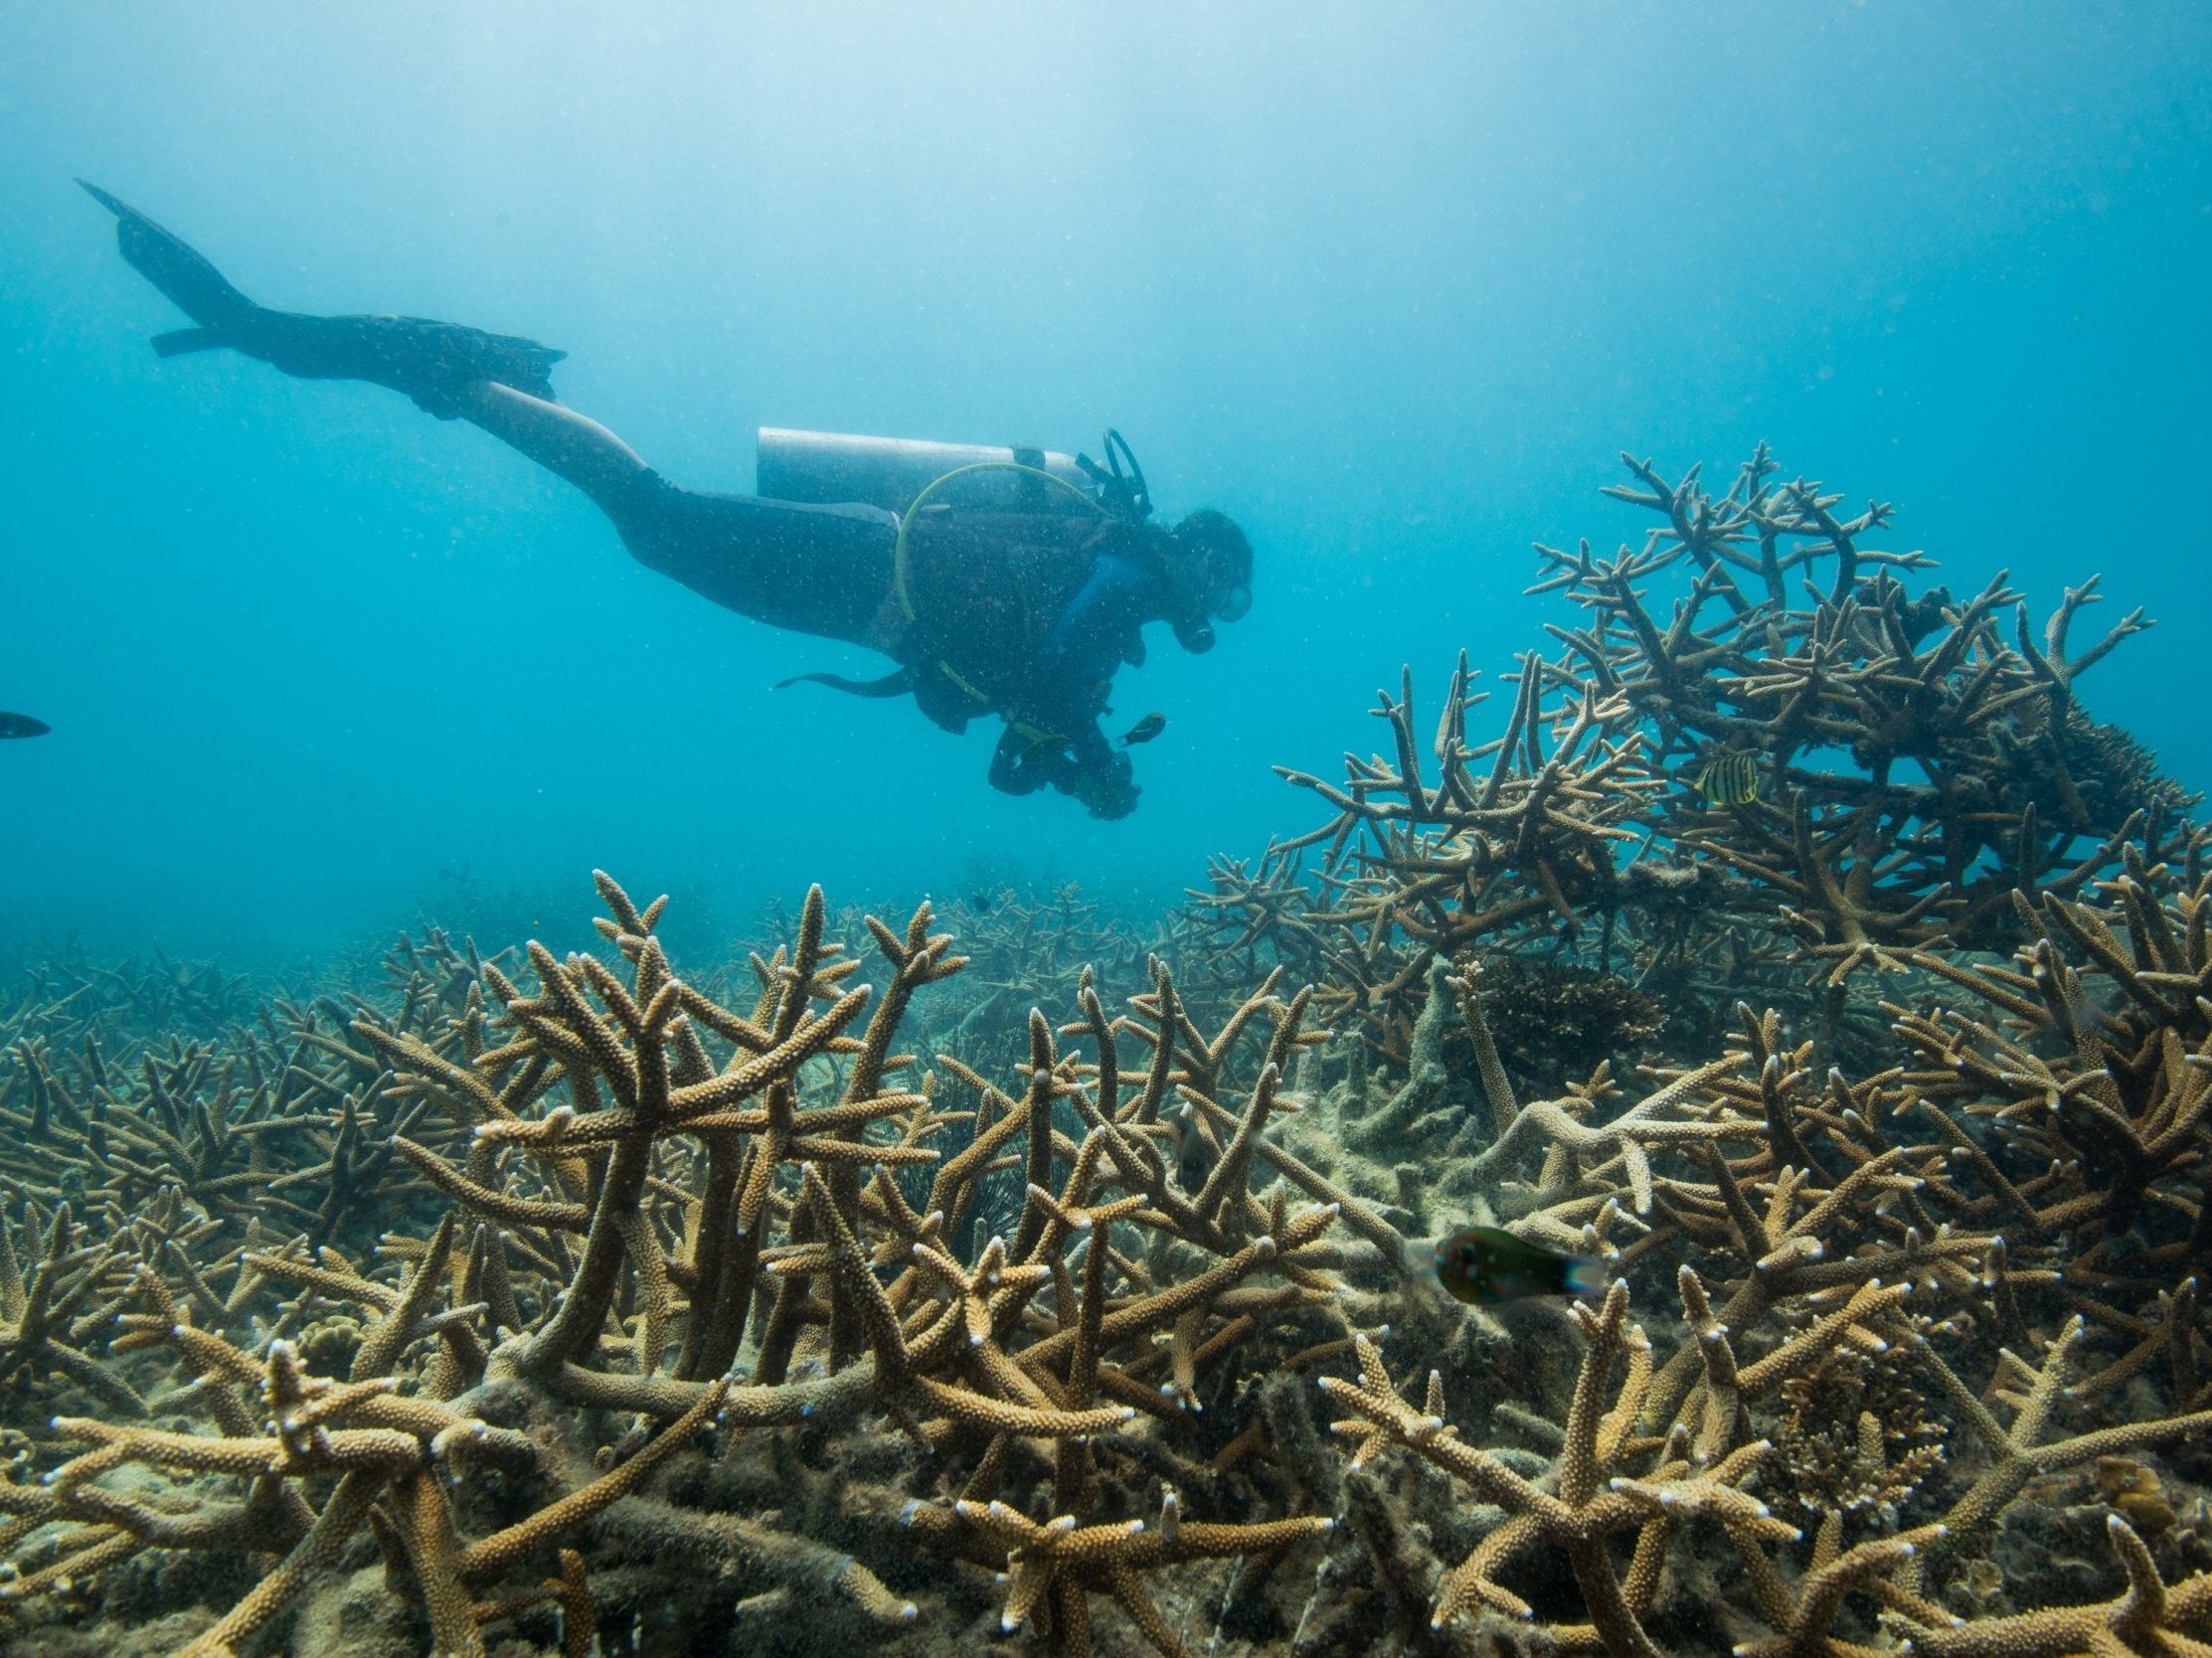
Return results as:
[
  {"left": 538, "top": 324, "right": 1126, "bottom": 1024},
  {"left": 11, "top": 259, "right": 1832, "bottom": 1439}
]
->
[{"left": 80, "top": 179, "right": 1252, "bottom": 818}]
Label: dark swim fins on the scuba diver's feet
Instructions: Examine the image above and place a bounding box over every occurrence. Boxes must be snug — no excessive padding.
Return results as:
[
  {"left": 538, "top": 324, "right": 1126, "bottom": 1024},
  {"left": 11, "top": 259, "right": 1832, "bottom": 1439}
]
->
[{"left": 78, "top": 179, "right": 569, "bottom": 417}]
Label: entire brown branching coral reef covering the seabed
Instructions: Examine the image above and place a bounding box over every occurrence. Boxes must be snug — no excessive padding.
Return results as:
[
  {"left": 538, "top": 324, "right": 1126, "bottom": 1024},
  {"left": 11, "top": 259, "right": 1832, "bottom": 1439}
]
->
[{"left": 0, "top": 453, "right": 2212, "bottom": 1658}]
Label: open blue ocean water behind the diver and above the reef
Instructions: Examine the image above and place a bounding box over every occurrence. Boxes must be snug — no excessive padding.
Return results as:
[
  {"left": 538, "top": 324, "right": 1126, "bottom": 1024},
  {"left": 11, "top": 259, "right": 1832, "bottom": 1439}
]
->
[{"left": 0, "top": 0, "right": 2212, "bottom": 957}]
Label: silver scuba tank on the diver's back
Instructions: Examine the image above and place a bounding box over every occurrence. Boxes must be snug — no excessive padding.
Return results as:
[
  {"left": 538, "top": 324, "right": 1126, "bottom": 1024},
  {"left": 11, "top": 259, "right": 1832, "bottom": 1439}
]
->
[{"left": 755, "top": 426, "right": 1095, "bottom": 513}]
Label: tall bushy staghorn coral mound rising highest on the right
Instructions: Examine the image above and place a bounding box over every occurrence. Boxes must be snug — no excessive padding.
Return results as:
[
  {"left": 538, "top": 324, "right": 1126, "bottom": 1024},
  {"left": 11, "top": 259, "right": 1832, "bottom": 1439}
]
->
[{"left": 1192, "top": 446, "right": 2194, "bottom": 1064}]
